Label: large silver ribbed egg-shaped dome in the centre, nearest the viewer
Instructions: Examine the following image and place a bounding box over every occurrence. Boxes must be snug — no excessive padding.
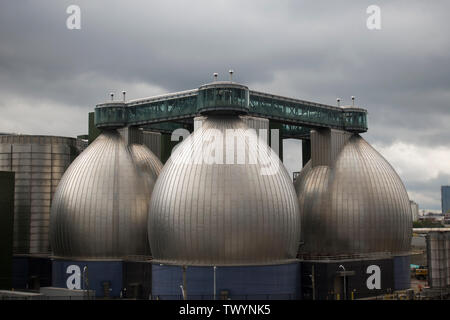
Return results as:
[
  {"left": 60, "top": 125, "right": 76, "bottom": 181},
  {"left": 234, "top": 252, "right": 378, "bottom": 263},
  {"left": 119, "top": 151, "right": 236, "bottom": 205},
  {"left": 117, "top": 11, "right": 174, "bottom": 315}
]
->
[{"left": 148, "top": 116, "right": 300, "bottom": 265}]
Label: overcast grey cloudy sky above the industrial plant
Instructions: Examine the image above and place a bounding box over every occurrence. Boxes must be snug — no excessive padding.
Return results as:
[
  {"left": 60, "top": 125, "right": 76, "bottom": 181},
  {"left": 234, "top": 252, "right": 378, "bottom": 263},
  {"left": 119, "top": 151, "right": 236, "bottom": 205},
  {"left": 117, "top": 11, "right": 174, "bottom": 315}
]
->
[{"left": 0, "top": 0, "right": 450, "bottom": 209}]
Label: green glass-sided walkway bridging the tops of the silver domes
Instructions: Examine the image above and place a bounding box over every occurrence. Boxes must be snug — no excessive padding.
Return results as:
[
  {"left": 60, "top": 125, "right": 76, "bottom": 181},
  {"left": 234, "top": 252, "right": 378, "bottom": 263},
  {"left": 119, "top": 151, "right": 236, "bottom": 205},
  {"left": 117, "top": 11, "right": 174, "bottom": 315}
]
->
[{"left": 89, "top": 81, "right": 367, "bottom": 162}]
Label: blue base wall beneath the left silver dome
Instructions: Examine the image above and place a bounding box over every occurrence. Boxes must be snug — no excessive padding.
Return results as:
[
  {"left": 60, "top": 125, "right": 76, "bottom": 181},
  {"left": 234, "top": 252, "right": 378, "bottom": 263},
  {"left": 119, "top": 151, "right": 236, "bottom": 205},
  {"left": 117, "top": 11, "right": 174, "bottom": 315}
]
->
[{"left": 52, "top": 259, "right": 123, "bottom": 297}]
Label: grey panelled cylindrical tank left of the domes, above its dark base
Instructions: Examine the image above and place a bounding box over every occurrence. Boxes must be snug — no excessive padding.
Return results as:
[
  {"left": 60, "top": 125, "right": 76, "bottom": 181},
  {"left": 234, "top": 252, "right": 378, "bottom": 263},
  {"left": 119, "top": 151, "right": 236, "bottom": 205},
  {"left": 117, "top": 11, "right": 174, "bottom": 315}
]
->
[{"left": 0, "top": 135, "right": 77, "bottom": 254}]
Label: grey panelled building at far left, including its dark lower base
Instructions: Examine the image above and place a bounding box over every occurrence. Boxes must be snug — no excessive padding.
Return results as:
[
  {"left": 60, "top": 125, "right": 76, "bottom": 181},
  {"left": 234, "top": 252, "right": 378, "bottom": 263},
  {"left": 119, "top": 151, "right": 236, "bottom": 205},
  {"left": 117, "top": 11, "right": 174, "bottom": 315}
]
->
[{"left": 0, "top": 134, "right": 83, "bottom": 288}]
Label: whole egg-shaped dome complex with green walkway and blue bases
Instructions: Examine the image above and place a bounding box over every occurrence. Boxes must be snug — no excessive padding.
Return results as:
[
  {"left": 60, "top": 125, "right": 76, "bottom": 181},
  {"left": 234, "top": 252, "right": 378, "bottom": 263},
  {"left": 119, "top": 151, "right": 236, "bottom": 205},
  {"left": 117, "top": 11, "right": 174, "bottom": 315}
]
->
[{"left": 0, "top": 75, "right": 420, "bottom": 299}]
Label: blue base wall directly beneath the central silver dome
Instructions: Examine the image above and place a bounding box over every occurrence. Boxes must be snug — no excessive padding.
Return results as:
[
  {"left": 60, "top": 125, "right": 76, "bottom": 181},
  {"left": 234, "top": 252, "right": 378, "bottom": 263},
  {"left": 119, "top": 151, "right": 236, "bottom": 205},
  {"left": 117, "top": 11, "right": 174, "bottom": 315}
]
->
[{"left": 152, "top": 262, "right": 301, "bottom": 300}]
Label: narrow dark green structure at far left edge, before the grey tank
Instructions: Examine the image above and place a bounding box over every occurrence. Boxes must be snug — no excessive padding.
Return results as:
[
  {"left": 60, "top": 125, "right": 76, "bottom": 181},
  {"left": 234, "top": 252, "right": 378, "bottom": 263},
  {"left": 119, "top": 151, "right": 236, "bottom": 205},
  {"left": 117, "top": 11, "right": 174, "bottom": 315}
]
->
[{"left": 0, "top": 171, "right": 15, "bottom": 290}]
